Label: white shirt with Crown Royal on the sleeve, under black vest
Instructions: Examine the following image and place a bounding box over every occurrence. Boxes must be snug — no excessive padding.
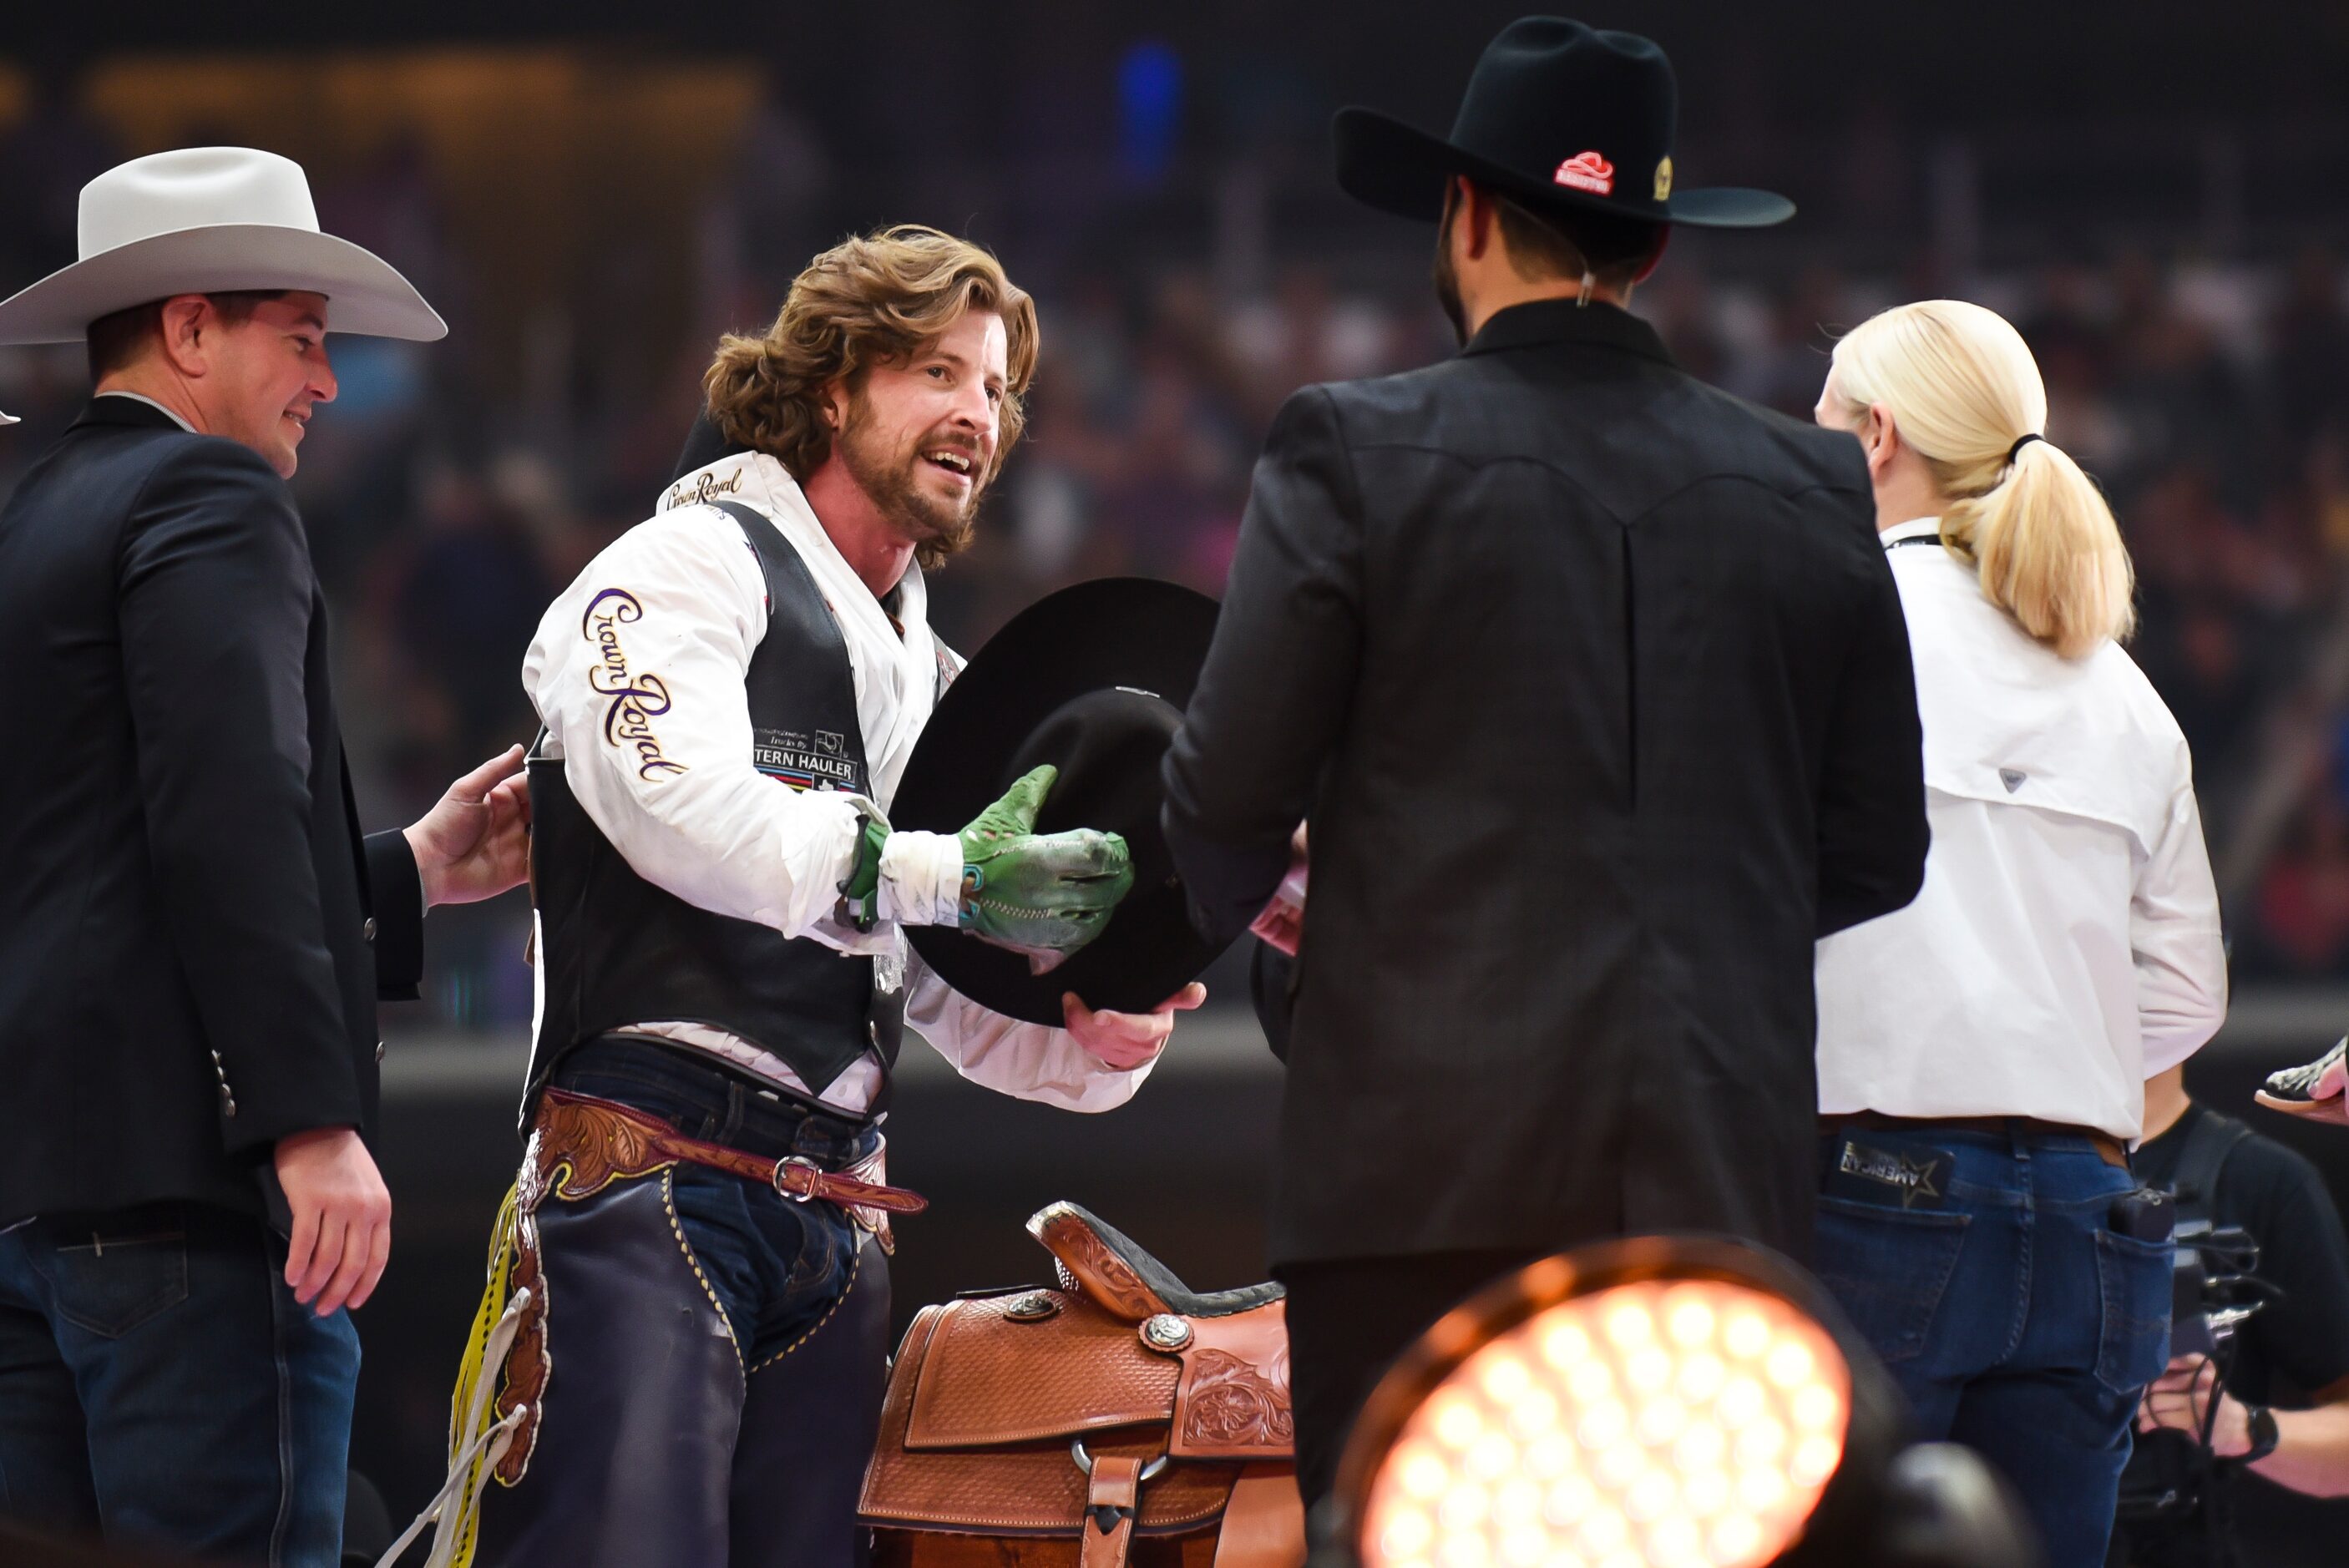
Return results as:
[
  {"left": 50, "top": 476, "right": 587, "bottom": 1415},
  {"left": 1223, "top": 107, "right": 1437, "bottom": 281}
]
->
[{"left": 521, "top": 453, "right": 1151, "bottom": 1110}]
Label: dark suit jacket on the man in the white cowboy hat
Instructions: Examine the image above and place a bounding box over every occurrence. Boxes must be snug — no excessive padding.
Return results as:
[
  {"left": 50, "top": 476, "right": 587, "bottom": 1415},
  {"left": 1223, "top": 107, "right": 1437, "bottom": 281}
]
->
[{"left": 0, "top": 397, "right": 423, "bottom": 1223}]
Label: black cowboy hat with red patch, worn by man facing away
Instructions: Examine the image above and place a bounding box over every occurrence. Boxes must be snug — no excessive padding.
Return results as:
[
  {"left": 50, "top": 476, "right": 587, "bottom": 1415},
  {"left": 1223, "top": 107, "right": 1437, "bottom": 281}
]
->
[{"left": 1332, "top": 17, "right": 1795, "bottom": 228}]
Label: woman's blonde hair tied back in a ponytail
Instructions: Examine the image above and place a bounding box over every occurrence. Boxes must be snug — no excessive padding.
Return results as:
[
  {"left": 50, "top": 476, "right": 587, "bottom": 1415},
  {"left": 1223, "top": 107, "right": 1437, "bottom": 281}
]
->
[{"left": 1832, "top": 301, "right": 2135, "bottom": 660}]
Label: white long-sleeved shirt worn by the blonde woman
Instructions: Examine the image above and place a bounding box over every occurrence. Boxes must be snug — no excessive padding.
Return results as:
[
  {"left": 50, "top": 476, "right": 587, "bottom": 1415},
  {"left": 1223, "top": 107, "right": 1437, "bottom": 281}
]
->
[{"left": 1818, "top": 518, "right": 2227, "bottom": 1141}]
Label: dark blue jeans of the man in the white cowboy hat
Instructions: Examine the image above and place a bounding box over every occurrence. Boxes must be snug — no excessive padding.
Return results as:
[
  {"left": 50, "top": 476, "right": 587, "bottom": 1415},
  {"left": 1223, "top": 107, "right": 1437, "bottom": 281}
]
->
[{"left": 0, "top": 1204, "right": 359, "bottom": 1568}]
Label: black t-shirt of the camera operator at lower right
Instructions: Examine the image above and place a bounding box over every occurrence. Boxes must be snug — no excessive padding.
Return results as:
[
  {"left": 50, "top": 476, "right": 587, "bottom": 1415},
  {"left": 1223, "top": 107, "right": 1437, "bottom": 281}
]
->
[{"left": 2130, "top": 1105, "right": 2349, "bottom": 1406}]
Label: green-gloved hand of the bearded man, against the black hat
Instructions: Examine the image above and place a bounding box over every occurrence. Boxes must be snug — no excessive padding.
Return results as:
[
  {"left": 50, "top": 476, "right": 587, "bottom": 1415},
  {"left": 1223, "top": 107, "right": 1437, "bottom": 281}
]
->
[{"left": 961, "top": 766, "right": 1135, "bottom": 974}]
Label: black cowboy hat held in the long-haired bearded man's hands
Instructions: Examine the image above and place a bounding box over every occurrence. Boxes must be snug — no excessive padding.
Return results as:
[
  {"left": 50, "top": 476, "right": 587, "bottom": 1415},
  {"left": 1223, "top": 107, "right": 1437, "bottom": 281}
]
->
[{"left": 890, "top": 578, "right": 1226, "bottom": 1028}]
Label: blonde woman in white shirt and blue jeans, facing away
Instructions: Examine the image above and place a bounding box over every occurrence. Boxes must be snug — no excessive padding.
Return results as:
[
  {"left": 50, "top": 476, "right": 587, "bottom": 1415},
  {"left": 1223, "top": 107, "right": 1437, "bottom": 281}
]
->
[{"left": 1815, "top": 301, "right": 2227, "bottom": 1568}]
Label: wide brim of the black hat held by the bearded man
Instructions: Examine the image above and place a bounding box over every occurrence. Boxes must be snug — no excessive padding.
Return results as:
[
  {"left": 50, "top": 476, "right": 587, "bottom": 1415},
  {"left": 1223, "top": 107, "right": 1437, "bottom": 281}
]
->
[{"left": 890, "top": 578, "right": 1228, "bottom": 1028}]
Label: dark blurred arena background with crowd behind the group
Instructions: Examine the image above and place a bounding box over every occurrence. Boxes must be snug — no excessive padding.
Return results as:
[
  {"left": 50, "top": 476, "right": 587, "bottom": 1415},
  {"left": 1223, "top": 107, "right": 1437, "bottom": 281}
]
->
[{"left": 0, "top": 0, "right": 2349, "bottom": 1563}]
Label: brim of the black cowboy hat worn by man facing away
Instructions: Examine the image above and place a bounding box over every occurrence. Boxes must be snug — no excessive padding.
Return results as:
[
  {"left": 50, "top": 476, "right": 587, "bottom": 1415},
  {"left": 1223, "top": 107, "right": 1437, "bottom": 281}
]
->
[{"left": 1329, "top": 108, "right": 1795, "bottom": 228}]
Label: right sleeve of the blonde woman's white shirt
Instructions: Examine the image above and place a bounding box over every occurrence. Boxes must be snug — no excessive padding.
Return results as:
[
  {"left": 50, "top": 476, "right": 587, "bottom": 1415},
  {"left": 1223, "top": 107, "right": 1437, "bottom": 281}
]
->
[{"left": 2129, "top": 741, "right": 2227, "bottom": 1077}]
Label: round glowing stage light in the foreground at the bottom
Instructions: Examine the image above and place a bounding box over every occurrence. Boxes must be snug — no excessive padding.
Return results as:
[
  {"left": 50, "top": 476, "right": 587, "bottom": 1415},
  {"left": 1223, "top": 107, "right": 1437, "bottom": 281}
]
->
[{"left": 1315, "top": 1237, "right": 2029, "bottom": 1568}]
